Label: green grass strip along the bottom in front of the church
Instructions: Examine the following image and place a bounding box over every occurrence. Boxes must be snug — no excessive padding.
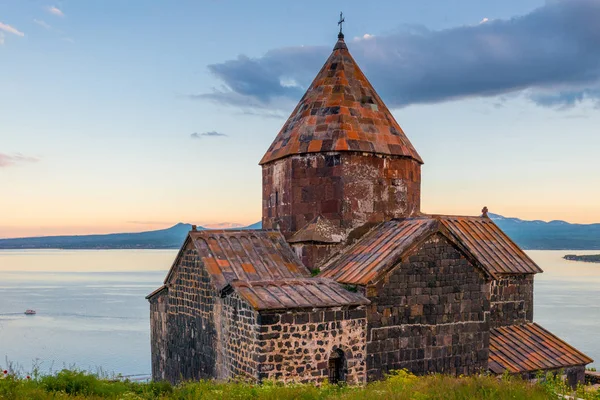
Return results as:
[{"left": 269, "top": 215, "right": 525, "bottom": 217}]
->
[{"left": 0, "top": 370, "right": 600, "bottom": 400}]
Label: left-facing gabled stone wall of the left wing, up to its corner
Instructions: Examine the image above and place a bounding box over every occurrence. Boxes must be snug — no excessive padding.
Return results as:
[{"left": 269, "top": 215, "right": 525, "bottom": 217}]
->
[{"left": 159, "top": 245, "right": 258, "bottom": 382}]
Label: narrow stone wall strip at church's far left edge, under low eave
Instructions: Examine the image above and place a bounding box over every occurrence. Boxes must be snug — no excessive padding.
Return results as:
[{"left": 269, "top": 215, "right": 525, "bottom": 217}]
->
[{"left": 149, "top": 289, "right": 169, "bottom": 381}]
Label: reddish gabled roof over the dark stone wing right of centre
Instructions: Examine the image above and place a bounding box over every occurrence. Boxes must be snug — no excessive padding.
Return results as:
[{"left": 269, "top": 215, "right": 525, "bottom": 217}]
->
[{"left": 320, "top": 215, "right": 542, "bottom": 285}]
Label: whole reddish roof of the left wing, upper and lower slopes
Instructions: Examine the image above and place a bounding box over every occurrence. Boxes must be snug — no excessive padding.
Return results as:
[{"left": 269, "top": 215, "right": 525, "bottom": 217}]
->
[{"left": 161, "top": 229, "right": 369, "bottom": 310}]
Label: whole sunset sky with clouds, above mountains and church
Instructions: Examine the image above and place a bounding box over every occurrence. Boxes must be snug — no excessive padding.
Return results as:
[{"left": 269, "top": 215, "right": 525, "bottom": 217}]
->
[{"left": 0, "top": 0, "right": 600, "bottom": 237}]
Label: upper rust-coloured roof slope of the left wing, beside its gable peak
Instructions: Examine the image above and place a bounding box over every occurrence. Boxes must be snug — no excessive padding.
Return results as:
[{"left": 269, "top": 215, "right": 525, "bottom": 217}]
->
[{"left": 183, "top": 230, "right": 310, "bottom": 290}]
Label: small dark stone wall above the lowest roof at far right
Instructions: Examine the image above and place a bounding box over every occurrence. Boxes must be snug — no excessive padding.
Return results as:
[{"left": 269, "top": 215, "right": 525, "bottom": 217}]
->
[{"left": 490, "top": 275, "right": 534, "bottom": 328}]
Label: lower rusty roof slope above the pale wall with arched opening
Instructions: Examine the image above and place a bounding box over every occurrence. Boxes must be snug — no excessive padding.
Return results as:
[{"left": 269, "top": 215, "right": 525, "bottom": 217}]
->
[{"left": 231, "top": 278, "right": 369, "bottom": 310}]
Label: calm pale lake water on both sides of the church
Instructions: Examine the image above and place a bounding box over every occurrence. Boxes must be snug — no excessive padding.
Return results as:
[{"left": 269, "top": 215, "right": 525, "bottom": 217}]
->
[{"left": 0, "top": 250, "right": 600, "bottom": 375}]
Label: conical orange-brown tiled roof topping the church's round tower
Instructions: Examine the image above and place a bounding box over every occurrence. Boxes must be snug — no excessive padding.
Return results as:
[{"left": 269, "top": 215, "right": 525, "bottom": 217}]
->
[{"left": 260, "top": 38, "right": 423, "bottom": 164}]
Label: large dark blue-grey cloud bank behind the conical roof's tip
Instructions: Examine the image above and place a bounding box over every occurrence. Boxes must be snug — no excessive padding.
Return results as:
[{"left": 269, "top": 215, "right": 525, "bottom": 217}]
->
[{"left": 198, "top": 0, "right": 600, "bottom": 110}]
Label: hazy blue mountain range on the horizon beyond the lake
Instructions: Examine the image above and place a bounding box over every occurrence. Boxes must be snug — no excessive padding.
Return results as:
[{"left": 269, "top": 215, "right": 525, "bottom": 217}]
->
[{"left": 0, "top": 214, "right": 600, "bottom": 250}]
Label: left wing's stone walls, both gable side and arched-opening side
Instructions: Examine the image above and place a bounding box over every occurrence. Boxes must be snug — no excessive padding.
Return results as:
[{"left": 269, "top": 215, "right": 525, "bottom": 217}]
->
[{"left": 150, "top": 239, "right": 366, "bottom": 383}]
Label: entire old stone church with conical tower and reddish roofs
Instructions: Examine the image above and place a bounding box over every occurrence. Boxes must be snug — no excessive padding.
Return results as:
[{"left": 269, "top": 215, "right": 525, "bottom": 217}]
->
[{"left": 147, "top": 34, "right": 592, "bottom": 384}]
